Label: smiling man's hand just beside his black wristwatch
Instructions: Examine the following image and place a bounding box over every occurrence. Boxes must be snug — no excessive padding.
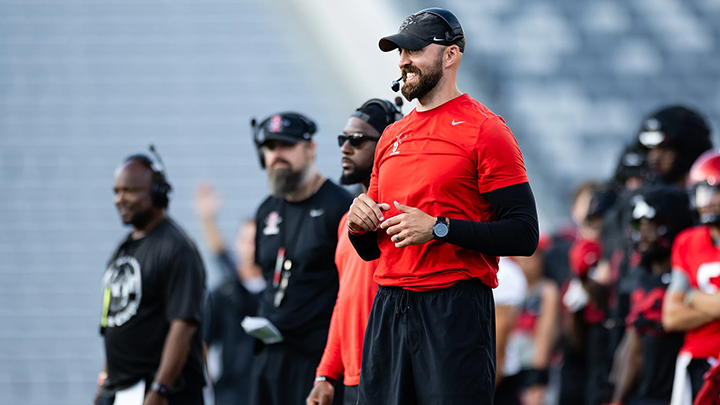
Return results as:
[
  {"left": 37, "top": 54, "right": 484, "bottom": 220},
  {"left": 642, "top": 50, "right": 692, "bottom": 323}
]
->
[{"left": 380, "top": 201, "right": 437, "bottom": 248}]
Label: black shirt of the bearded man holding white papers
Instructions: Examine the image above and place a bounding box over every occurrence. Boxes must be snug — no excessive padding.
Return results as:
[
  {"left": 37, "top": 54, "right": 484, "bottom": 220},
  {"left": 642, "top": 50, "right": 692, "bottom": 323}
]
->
[{"left": 255, "top": 180, "right": 352, "bottom": 353}]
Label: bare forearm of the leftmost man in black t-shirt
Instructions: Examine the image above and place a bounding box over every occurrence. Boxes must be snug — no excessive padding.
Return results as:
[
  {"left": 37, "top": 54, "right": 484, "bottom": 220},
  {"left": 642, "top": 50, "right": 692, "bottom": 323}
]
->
[{"left": 155, "top": 320, "right": 197, "bottom": 387}]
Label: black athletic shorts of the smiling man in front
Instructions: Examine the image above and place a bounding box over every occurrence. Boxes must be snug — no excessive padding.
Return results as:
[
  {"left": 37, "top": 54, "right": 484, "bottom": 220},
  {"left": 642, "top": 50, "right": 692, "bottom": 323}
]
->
[{"left": 358, "top": 280, "right": 495, "bottom": 405}]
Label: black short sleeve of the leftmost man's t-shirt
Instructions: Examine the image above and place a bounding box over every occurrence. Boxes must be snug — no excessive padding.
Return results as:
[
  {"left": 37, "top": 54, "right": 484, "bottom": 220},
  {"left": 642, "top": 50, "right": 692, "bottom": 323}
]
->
[{"left": 165, "top": 246, "right": 205, "bottom": 323}]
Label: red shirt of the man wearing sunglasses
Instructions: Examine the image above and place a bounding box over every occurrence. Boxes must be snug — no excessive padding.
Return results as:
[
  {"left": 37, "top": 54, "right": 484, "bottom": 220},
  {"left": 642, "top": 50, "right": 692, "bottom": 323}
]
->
[{"left": 317, "top": 213, "right": 378, "bottom": 386}]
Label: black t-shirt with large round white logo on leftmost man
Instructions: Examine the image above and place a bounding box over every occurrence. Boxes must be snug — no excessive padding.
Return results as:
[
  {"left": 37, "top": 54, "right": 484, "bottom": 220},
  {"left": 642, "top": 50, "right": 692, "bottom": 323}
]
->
[{"left": 101, "top": 219, "right": 205, "bottom": 393}]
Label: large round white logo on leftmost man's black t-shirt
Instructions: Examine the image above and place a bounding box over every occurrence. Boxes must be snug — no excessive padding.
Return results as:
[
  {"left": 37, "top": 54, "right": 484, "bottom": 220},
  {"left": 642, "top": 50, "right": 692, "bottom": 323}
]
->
[{"left": 102, "top": 256, "right": 142, "bottom": 328}]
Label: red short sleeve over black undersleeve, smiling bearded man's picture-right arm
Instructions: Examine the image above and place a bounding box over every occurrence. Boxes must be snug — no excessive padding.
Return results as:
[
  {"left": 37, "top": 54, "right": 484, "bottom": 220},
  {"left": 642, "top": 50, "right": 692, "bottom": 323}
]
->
[{"left": 476, "top": 116, "right": 528, "bottom": 194}]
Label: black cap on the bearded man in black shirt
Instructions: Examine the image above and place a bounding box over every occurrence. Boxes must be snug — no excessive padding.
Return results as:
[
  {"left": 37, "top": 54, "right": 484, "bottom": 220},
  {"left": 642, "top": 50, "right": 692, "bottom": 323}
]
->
[{"left": 252, "top": 112, "right": 317, "bottom": 146}]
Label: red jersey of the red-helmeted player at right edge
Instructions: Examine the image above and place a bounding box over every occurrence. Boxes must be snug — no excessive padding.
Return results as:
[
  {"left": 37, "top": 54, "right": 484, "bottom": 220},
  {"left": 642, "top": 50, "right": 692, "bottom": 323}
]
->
[{"left": 672, "top": 226, "right": 720, "bottom": 358}]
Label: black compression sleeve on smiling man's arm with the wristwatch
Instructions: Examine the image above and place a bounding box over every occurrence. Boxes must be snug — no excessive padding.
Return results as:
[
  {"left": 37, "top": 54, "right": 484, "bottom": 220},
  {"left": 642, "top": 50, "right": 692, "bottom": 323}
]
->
[{"left": 445, "top": 183, "right": 539, "bottom": 256}]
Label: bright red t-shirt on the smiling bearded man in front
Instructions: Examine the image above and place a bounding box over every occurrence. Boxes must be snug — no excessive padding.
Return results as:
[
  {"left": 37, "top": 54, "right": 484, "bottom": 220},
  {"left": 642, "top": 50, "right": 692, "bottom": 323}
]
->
[{"left": 368, "top": 94, "right": 528, "bottom": 291}]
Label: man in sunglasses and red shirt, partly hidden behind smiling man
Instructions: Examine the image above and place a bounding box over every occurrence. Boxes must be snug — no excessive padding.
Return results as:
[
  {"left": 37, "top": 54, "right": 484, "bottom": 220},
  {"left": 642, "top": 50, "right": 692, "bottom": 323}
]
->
[{"left": 306, "top": 98, "right": 402, "bottom": 405}]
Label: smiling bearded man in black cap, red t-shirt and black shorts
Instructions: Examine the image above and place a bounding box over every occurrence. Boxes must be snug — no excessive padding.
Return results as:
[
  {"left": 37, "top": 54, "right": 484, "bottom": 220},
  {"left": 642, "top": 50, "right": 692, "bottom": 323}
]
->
[{"left": 348, "top": 8, "right": 538, "bottom": 405}]
